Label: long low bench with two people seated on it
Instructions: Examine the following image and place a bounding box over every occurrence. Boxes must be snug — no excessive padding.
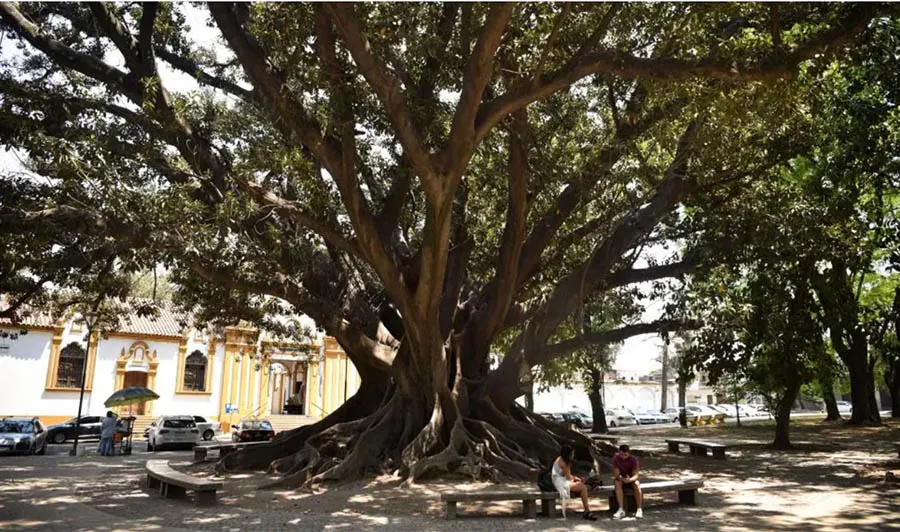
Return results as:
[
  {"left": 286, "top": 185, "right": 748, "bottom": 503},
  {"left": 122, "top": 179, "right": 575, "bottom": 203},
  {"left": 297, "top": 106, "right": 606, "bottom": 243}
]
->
[{"left": 441, "top": 479, "right": 703, "bottom": 519}]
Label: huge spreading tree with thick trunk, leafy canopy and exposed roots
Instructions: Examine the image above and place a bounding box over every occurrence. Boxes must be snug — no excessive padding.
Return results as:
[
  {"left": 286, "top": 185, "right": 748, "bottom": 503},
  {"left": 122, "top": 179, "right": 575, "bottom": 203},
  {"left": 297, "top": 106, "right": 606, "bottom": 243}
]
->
[{"left": 0, "top": 3, "right": 889, "bottom": 483}]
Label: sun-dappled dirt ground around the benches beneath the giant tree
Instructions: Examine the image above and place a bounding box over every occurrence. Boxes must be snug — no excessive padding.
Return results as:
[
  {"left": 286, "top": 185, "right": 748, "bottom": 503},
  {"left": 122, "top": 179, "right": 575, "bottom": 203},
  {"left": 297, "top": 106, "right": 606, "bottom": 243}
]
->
[{"left": 0, "top": 420, "right": 900, "bottom": 532}]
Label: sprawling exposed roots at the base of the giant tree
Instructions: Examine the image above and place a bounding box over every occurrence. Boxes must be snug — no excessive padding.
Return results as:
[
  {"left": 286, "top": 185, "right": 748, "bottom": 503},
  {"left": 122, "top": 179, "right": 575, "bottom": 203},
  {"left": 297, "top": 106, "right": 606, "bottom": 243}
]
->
[{"left": 243, "top": 393, "right": 615, "bottom": 488}]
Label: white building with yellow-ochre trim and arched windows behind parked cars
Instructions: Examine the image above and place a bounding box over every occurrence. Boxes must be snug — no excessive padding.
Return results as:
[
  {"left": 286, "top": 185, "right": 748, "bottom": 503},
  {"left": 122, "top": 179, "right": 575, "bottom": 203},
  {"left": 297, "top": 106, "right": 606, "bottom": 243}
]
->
[{"left": 0, "top": 305, "right": 359, "bottom": 428}]
